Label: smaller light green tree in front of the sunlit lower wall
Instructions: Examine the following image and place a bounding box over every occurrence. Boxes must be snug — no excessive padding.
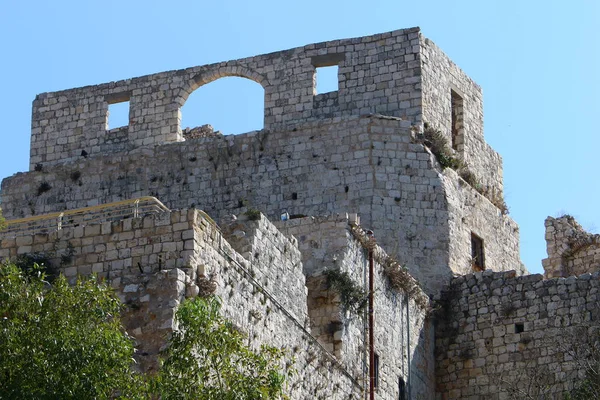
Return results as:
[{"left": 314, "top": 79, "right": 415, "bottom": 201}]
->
[{"left": 154, "top": 297, "right": 291, "bottom": 400}]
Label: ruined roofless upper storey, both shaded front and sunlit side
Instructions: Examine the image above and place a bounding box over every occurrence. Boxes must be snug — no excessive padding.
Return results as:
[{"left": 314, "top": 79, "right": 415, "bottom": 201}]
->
[{"left": 30, "top": 28, "right": 502, "bottom": 195}]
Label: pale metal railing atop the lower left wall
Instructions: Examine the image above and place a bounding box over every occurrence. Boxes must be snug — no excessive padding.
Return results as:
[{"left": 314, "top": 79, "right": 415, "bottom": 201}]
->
[{"left": 0, "top": 196, "right": 170, "bottom": 237}]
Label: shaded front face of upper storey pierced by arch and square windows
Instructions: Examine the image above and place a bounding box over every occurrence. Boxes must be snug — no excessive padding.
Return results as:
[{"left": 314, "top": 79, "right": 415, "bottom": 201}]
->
[{"left": 30, "top": 28, "right": 421, "bottom": 170}]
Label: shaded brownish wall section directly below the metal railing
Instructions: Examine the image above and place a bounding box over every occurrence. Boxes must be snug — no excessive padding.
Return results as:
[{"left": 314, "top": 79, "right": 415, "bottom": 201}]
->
[{"left": 0, "top": 212, "right": 193, "bottom": 370}]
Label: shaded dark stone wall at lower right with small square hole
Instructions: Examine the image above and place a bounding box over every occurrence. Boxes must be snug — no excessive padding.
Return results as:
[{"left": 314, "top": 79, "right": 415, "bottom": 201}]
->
[{"left": 435, "top": 271, "right": 600, "bottom": 399}]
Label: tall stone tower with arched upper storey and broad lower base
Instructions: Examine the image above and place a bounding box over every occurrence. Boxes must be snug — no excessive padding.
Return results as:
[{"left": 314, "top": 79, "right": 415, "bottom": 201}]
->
[{"left": 2, "top": 28, "right": 521, "bottom": 294}]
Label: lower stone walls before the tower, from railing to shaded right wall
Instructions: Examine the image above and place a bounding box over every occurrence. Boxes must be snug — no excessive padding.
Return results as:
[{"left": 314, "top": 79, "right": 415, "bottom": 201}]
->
[{"left": 0, "top": 210, "right": 434, "bottom": 399}]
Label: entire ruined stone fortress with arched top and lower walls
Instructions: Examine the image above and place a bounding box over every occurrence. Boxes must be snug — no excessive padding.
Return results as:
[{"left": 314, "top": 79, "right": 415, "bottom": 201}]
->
[{"left": 0, "top": 28, "right": 600, "bottom": 399}]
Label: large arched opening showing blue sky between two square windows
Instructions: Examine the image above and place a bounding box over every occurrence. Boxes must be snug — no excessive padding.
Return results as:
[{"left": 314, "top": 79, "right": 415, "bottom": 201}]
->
[{"left": 180, "top": 77, "right": 265, "bottom": 138}]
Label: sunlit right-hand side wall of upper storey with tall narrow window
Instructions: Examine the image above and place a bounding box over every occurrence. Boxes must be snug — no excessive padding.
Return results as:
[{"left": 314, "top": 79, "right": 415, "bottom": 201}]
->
[{"left": 421, "top": 36, "right": 504, "bottom": 197}]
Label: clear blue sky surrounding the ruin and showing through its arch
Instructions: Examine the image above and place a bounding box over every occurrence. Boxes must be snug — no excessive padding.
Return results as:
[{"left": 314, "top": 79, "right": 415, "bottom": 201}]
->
[{"left": 0, "top": 0, "right": 600, "bottom": 272}]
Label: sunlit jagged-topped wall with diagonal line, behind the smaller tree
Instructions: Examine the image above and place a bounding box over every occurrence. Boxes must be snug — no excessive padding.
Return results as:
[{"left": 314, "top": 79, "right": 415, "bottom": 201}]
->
[{"left": 189, "top": 213, "right": 362, "bottom": 400}]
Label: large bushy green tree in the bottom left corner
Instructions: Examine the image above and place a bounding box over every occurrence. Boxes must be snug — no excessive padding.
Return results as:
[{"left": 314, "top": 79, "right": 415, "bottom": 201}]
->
[{"left": 0, "top": 263, "right": 143, "bottom": 399}]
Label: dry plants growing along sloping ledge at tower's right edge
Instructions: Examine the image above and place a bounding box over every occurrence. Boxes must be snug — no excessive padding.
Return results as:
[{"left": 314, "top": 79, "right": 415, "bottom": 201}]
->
[{"left": 417, "top": 123, "right": 509, "bottom": 215}]
